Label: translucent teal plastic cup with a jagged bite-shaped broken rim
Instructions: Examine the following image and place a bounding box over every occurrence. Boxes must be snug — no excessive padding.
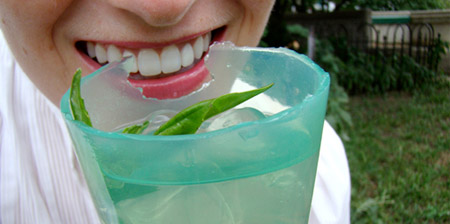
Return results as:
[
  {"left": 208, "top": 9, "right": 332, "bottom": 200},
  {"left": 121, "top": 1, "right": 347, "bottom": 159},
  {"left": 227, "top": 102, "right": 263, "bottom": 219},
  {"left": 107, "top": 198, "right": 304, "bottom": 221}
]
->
[{"left": 61, "top": 44, "right": 330, "bottom": 224}]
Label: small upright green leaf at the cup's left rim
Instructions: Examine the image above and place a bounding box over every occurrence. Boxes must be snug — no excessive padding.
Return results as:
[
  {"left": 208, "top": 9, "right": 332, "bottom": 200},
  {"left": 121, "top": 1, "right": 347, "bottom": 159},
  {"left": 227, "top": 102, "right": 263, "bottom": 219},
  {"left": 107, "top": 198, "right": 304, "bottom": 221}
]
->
[{"left": 69, "top": 69, "right": 92, "bottom": 127}]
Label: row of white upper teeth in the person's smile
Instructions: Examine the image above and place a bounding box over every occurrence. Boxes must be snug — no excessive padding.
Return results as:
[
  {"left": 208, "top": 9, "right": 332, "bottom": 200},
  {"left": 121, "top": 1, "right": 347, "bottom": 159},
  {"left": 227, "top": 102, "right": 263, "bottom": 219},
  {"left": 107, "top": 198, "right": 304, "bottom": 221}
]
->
[{"left": 87, "top": 33, "right": 211, "bottom": 76}]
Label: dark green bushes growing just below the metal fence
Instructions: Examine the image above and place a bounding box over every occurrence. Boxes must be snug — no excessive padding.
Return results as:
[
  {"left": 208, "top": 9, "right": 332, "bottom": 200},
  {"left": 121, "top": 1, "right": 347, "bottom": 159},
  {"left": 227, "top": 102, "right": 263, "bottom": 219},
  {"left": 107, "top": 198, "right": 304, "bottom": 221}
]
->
[{"left": 322, "top": 37, "right": 446, "bottom": 95}]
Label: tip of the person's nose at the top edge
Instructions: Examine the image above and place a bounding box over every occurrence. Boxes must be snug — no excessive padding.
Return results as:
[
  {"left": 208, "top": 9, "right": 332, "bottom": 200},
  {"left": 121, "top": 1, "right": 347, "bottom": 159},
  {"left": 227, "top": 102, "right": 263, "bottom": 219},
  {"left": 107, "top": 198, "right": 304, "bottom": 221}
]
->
[{"left": 109, "top": 0, "right": 194, "bottom": 27}]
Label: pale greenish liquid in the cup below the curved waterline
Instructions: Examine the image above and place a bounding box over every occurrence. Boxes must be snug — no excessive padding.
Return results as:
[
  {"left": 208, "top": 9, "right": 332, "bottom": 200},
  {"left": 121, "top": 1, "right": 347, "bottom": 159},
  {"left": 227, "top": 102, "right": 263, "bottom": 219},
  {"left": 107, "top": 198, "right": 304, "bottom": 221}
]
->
[{"left": 105, "top": 147, "right": 317, "bottom": 224}]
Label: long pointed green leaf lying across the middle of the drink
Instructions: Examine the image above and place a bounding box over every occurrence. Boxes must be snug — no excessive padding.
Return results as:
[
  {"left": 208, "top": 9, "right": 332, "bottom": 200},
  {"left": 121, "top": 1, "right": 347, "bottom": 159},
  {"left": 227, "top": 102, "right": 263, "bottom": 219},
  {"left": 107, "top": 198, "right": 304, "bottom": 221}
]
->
[{"left": 154, "top": 83, "right": 273, "bottom": 135}]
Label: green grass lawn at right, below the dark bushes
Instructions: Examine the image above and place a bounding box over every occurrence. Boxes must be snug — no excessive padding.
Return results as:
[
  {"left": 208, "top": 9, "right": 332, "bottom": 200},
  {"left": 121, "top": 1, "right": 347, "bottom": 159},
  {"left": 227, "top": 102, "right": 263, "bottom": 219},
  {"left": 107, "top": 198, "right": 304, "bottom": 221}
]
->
[{"left": 345, "top": 82, "right": 450, "bottom": 223}]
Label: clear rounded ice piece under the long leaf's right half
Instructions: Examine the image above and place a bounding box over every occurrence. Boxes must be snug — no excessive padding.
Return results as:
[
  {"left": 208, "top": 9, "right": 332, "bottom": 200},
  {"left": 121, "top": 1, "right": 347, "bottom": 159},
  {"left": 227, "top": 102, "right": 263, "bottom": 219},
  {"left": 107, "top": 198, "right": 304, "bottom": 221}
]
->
[{"left": 198, "top": 107, "right": 266, "bottom": 133}]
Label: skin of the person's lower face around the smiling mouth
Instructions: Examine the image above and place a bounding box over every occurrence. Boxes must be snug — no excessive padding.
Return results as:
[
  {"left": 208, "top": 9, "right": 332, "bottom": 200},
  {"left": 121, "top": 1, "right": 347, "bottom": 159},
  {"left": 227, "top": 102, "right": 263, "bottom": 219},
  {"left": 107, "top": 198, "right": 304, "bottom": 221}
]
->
[{"left": 0, "top": 0, "right": 274, "bottom": 105}]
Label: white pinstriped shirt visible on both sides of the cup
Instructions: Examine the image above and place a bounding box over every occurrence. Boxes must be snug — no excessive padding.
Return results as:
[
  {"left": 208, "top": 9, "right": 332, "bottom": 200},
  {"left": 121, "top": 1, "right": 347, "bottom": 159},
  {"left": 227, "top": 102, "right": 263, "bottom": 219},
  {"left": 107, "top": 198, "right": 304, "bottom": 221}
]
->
[{"left": 0, "top": 32, "right": 350, "bottom": 224}]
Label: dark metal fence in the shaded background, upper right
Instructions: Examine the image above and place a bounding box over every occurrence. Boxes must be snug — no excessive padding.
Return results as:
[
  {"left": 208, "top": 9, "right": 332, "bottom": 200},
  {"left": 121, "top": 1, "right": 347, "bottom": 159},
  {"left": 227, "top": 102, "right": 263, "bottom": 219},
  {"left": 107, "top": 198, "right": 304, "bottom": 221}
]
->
[{"left": 310, "top": 22, "right": 440, "bottom": 70}]
